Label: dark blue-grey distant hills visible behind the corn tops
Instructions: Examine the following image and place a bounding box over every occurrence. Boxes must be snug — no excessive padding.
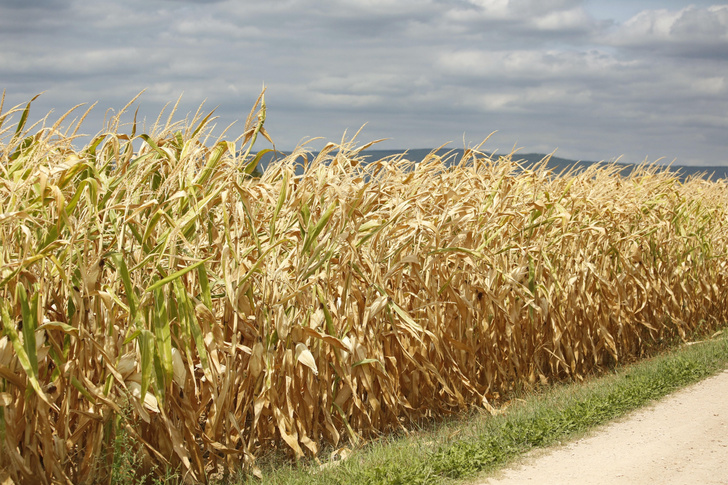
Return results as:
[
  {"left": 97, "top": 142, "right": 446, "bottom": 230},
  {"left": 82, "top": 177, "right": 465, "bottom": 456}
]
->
[{"left": 249, "top": 148, "right": 728, "bottom": 180}]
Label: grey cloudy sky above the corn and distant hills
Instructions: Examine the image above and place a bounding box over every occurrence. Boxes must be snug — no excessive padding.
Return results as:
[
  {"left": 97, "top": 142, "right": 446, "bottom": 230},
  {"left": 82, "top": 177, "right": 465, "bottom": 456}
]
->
[{"left": 0, "top": 0, "right": 728, "bottom": 165}]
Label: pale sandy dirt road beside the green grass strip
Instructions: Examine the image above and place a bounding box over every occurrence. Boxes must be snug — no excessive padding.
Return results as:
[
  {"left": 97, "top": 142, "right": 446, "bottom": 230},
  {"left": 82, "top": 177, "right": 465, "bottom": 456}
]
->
[{"left": 482, "top": 370, "right": 728, "bottom": 485}]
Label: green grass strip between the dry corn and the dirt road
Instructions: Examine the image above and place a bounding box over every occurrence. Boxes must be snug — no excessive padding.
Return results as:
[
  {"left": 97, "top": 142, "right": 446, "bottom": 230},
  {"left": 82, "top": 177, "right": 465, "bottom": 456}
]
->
[{"left": 234, "top": 332, "right": 728, "bottom": 485}]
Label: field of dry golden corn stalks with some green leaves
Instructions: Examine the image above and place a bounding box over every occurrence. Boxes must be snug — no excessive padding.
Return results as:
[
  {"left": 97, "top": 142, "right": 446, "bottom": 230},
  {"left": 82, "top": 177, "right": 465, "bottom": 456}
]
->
[{"left": 0, "top": 94, "right": 728, "bottom": 484}]
